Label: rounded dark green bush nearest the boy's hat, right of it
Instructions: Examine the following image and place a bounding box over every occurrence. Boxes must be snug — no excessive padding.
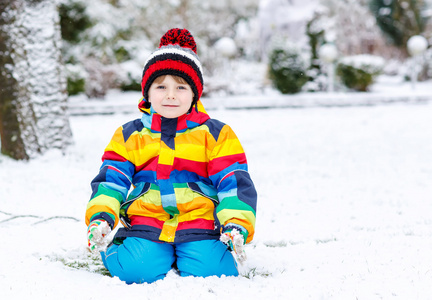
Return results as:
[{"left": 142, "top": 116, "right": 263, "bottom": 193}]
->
[{"left": 269, "top": 45, "right": 308, "bottom": 94}]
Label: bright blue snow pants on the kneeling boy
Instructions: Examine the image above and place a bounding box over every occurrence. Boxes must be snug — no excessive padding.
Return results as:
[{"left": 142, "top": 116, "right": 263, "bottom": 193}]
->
[{"left": 101, "top": 237, "right": 239, "bottom": 284}]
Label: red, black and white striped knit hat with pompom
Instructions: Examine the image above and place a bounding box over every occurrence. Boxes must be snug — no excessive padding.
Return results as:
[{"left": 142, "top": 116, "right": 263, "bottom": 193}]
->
[{"left": 139, "top": 28, "right": 204, "bottom": 109}]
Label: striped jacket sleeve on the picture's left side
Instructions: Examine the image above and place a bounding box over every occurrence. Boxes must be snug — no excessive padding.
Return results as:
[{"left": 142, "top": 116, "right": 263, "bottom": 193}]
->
[{"left": 85, "top": 127, "right": 135, "bottom": 228}]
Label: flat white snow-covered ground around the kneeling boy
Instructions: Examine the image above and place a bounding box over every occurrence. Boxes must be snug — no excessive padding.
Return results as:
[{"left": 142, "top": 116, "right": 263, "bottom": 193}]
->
[{"left": 0, "top": 86, "right": 432, "bottom": 300}]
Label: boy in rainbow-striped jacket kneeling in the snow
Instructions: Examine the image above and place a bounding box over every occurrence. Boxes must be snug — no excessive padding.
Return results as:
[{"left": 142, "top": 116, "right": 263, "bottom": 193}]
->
[{"left": 86, "top": 28, "right": 257, "bottom": 283}]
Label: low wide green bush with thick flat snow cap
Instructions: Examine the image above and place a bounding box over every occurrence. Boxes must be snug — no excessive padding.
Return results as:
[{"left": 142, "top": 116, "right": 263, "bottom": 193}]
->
[{"left": 336, "top": 54, "right": 384, "bottom": 91}]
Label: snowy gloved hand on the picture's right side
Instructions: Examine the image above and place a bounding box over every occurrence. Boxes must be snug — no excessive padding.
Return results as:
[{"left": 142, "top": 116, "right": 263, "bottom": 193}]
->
[{"left": 220, "top": 223, "right": 248, "bottom": 263}]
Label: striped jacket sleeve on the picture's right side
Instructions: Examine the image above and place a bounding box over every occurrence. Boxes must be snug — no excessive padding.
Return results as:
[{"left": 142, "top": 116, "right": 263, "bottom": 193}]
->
[{"left": 208, "top": 125, "right": 257, "bottom": 243}]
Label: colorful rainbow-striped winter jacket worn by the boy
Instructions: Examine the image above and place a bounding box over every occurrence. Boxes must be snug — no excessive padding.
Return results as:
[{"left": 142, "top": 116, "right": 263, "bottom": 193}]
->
[{"left": 86, "top": 101, "right": 257, "bottom": 243}]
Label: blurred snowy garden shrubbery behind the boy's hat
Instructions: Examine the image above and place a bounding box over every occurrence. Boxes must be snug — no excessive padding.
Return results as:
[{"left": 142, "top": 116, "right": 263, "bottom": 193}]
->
[{"left": 60, "top": 0, "right": 432, "bottom": 98}]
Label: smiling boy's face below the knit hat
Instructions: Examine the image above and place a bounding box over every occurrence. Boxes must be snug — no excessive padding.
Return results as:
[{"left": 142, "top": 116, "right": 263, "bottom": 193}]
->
[{"left": 148, "top": 75, "right": 194, "bottom": 119}]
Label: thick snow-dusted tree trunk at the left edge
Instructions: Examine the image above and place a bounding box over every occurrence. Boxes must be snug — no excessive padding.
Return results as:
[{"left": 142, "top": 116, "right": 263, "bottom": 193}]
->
[{"left": 0, "top": 0, "right": 72, "bottom": 159}]
